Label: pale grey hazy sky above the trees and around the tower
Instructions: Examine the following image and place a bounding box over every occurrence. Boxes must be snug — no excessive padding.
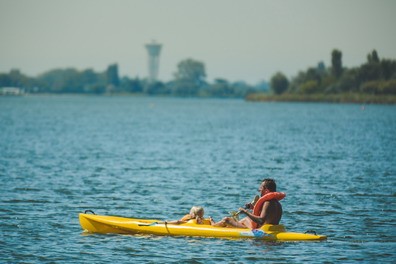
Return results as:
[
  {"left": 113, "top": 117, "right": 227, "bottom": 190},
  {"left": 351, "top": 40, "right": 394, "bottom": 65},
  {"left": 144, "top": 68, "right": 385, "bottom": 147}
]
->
[{"left": 0, "top": 0, "right": 396, "bottom": 84}]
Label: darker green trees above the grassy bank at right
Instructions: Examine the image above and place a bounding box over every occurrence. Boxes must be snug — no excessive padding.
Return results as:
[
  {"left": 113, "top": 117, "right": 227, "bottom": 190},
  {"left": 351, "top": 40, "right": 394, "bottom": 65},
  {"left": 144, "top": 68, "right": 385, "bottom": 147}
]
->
[{"left": 270, "top": 49, "right": 396, "bottom": 95}]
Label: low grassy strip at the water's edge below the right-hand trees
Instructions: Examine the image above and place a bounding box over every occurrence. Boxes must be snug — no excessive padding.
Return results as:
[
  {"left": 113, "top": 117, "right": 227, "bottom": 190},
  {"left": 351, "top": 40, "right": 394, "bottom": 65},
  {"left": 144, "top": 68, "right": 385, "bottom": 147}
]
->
[{"left": 245, "top": 93, "right": 396, "bottom": 104}]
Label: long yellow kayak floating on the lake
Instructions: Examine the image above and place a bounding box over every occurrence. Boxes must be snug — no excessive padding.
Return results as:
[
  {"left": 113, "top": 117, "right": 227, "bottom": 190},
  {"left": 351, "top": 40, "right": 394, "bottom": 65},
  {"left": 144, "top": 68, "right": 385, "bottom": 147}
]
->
[{"left": 79, "top": 213, "right": 327, "bottom": 241}]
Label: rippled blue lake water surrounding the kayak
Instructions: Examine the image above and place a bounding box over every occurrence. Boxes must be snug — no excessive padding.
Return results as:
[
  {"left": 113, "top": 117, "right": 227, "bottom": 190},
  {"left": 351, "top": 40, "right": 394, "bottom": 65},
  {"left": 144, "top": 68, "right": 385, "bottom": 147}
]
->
[{"left": 0, "top": 96, "right": 396, "bottom": 263}]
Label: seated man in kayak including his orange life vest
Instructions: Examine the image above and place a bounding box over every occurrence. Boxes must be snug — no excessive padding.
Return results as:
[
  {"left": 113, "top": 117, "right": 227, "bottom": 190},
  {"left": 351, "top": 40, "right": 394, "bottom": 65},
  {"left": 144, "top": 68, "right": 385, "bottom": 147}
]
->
[{"left": 212, "top": 179, "right": 285, "bottom": 229}]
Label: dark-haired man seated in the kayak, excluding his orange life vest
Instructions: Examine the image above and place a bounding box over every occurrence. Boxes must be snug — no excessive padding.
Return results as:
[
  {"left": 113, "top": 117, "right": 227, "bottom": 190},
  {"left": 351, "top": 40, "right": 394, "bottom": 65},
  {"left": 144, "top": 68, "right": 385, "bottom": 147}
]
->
[{"left": 212, "top": 179, "right": 282, "bottom": 228}]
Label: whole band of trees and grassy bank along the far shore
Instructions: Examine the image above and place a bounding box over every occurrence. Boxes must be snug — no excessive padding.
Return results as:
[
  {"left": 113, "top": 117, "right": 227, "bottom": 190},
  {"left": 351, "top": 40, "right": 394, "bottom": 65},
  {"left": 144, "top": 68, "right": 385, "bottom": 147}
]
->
[{"left": 0, "top": 49, "right": 396, "bottom": 104}]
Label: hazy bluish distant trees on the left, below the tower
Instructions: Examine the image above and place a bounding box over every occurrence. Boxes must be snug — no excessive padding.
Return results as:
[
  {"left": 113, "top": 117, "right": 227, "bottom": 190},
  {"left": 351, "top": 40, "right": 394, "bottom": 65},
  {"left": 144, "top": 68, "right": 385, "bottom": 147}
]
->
[{"left": 0, "top": 59, "right": 260, "bottom": 98}]
